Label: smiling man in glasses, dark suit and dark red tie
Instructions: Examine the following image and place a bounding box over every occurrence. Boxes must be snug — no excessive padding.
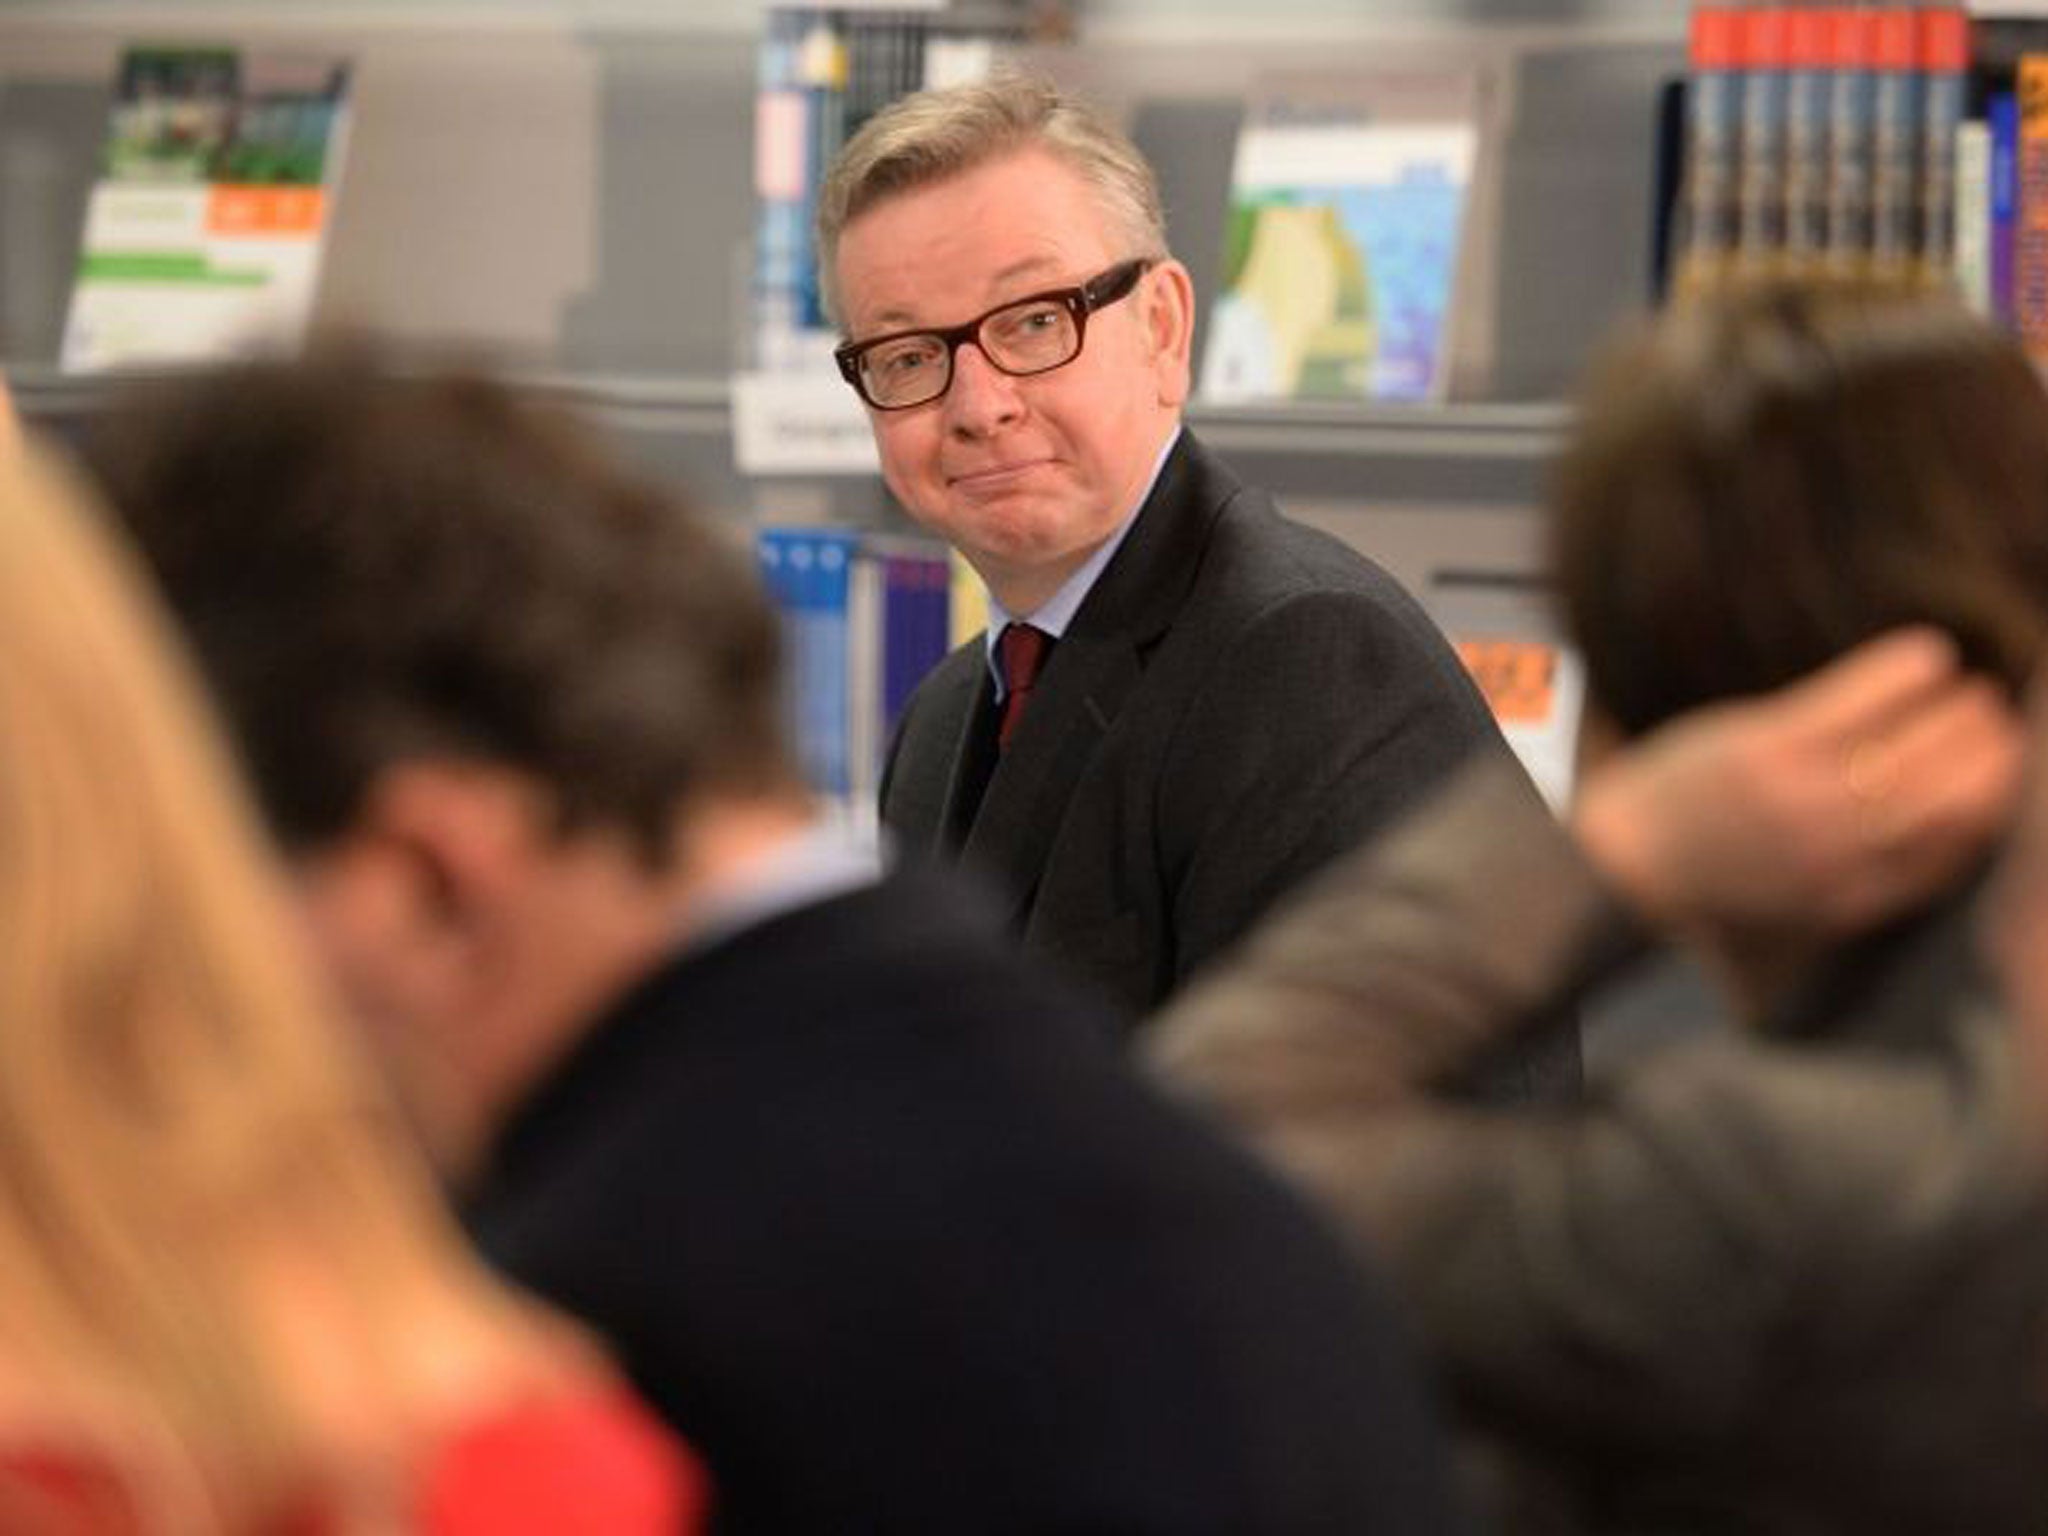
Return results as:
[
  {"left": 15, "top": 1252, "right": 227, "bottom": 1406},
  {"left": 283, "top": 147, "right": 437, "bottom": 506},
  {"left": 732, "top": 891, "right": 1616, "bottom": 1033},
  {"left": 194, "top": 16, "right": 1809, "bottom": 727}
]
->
[{"left": 819, "top": 76, "right": 1575, "bottom": 1087}]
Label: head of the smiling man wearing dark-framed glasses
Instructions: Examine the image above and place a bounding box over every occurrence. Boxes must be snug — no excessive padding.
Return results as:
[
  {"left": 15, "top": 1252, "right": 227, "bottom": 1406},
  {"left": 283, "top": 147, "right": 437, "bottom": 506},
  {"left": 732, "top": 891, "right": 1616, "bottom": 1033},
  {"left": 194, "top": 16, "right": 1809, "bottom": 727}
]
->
[{"left": 817, "top": 74, "right": 1194, "bottom": 614}]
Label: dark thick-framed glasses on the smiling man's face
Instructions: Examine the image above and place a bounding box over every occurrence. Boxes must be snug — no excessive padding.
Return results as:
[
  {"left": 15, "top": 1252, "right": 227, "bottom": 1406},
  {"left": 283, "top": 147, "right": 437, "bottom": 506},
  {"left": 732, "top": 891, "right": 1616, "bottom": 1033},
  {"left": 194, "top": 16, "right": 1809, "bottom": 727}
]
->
[{"left": 831, "top": 256, "right": 1151, "bottom": 412}]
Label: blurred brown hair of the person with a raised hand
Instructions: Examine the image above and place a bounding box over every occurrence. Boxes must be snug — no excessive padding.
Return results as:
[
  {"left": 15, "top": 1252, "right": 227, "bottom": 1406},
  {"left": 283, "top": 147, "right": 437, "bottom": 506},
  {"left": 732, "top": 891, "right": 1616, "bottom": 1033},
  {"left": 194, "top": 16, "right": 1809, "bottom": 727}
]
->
[{"left": 1550, "top": 283, "right": 2048, "bottom": 735}]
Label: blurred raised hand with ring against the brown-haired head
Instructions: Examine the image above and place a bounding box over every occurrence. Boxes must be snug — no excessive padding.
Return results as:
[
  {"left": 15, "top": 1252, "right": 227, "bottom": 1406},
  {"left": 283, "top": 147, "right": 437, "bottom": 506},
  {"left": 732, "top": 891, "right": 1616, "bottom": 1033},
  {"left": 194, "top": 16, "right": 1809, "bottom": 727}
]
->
[{"left": 1573, "top": 629, "right": 2023, "bottom": 934}]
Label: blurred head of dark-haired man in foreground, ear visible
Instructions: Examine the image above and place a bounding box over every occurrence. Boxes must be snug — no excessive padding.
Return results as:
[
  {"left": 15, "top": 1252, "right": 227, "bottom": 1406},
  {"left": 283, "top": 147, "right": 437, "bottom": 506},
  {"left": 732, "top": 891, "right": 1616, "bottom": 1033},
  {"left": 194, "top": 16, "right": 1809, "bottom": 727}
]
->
[{"left": 98, "top": 350, "right": 807, "bottom": 1165}]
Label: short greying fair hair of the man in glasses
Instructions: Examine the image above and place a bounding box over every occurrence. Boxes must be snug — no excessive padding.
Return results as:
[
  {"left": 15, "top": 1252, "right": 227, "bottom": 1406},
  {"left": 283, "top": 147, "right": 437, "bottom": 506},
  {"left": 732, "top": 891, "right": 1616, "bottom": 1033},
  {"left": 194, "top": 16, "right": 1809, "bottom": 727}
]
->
[{"left": 817, "top": 70, "right": 1169, "bottom": 329}]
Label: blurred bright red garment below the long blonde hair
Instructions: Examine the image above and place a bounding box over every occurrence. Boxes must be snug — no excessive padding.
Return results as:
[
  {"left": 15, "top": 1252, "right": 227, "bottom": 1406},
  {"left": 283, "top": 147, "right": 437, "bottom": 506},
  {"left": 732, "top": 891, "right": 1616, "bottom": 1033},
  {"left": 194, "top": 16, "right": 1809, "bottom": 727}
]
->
[{"left": 0, "top": 1391, "right": 711, "bottom": 1536}]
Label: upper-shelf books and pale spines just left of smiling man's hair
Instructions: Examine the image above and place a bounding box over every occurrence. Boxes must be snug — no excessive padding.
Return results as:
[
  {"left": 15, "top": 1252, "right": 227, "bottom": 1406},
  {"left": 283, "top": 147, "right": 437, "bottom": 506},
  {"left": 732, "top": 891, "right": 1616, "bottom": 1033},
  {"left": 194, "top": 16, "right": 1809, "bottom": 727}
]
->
[{"left": 754, "top": 8, "right": 993, "bottom": 367}]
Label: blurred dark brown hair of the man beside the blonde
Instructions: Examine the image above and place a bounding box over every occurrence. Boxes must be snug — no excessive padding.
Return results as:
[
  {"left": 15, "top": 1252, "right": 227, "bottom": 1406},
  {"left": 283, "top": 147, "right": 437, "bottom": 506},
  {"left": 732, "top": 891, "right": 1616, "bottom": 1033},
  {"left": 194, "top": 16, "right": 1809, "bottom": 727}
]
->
[{"left": 92, "top": 344, "right": 791, "bottom": 856}]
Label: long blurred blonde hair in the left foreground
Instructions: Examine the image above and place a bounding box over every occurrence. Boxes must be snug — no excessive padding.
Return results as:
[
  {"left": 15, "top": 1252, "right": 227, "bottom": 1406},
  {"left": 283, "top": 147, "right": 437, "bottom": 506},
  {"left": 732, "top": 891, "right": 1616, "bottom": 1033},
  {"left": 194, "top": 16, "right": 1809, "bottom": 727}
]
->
[{"left": 0, "top": 446, "right": 544, "bottom": 1530}]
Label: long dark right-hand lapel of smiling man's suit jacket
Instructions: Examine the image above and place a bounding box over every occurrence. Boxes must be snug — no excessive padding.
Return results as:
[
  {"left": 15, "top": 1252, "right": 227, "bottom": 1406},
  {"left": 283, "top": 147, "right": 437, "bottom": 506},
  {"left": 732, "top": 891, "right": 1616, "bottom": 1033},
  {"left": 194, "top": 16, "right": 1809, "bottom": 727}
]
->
[{"left": 954, "top": 430, "right": 1237, "bottom": 920}]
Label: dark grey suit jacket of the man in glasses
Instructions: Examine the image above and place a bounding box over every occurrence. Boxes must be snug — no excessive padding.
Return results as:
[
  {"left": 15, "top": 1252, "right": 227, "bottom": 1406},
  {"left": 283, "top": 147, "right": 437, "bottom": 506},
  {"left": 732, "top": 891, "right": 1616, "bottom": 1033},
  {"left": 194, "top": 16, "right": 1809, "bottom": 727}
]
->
[{"left": 881, "top": 432, "right": 1534, "bottom": 1040}]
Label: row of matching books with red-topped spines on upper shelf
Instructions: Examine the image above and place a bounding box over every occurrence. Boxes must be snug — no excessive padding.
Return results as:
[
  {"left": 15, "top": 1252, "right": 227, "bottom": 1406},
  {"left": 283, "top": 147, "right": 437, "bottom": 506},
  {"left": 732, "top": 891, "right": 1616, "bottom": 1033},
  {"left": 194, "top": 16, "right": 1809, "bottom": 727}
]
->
[{"left": 1677, "top": 0, "right": 1970, "bottom": 293}]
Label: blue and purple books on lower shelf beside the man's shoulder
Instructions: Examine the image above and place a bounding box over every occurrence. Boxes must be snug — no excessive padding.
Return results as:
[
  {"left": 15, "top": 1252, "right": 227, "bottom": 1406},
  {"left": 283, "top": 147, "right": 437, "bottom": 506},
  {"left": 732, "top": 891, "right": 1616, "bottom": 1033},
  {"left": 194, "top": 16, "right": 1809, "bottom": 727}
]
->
[{"left": 754, "top": 526, "right": 987, "bottom": 807}]
